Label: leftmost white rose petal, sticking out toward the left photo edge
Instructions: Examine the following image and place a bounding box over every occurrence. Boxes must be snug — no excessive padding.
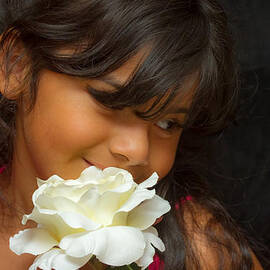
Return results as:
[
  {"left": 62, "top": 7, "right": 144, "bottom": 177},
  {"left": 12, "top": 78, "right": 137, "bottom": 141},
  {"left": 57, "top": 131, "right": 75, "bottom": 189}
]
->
[{"left": 9, "top": 228, "right": 58, "bottom": 255}]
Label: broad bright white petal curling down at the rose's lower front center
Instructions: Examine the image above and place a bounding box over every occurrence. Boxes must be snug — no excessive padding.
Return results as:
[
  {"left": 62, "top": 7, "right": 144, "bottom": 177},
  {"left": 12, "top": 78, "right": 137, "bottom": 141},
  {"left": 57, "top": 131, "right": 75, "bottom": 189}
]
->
[{"left": 59, "top": 226, "right": 145, "bottom": 266}]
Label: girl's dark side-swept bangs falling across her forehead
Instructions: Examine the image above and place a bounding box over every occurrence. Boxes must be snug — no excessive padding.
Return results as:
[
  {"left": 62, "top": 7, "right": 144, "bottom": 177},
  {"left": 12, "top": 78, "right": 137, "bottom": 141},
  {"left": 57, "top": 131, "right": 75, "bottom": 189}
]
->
[{"left": 32, "top": 1, "right": 208, "bottom": 119}]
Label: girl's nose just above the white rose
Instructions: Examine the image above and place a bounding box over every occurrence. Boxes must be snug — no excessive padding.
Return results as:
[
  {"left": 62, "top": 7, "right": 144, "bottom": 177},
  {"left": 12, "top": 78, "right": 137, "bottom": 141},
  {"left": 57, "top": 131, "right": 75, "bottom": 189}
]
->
[{"left": 109, "top": 125, "right": 149, "bottom": 166}]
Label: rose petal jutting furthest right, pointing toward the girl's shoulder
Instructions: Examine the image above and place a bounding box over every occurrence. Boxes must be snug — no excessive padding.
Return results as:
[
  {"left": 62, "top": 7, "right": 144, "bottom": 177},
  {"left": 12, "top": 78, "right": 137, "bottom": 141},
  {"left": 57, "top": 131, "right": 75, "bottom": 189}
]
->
[{"left": 127, "top": 195, "right": 171, "bottom": 230}]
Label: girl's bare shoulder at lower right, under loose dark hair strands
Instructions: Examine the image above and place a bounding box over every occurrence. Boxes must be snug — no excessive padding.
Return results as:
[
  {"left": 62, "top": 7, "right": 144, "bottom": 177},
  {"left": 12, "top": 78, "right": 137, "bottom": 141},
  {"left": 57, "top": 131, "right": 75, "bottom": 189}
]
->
[{"left": 175, "top": 196, "right": 263, "bottom": 270}]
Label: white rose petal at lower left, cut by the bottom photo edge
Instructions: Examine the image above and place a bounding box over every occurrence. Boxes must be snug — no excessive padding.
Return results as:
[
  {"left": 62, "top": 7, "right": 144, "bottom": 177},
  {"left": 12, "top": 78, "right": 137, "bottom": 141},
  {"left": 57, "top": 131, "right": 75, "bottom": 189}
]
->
[{"left": 29, "top": 248, "right": 91, "bottom": 270}]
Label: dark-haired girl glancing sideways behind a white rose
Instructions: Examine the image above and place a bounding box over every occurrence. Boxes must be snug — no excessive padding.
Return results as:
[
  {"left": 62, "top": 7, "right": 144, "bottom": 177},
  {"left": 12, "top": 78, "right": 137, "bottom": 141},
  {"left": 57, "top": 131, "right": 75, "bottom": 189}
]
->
[{"left": 0, "top": 0, "right": 261, "bottom": 270}]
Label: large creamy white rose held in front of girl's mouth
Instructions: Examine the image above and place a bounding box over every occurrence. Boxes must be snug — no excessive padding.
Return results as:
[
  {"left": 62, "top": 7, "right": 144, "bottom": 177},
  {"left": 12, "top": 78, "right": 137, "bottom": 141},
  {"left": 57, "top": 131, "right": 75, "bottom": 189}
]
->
[{"left": 10, "top": 166, "right": 170, "bottom": 270}]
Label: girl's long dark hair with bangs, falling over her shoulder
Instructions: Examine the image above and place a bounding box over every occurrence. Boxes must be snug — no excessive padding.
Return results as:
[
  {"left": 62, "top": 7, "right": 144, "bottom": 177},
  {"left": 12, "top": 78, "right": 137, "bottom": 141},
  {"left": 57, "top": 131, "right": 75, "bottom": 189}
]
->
[{"left": 0, "top": 0, "right": 258, "bottom": 270}]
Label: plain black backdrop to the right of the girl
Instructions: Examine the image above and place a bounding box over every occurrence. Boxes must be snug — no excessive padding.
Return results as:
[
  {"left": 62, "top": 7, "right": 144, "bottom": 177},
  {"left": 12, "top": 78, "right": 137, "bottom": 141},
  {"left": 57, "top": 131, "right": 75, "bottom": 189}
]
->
[{"left": 0, "top": 0, "right": 270, "bottom": 269}]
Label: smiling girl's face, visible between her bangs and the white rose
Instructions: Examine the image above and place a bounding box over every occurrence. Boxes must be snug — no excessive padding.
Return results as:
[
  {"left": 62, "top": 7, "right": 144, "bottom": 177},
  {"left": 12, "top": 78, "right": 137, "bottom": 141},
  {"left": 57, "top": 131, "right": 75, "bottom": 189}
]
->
[{"left": 13, "top": 50, "right": 194, "bottom": 192}]
